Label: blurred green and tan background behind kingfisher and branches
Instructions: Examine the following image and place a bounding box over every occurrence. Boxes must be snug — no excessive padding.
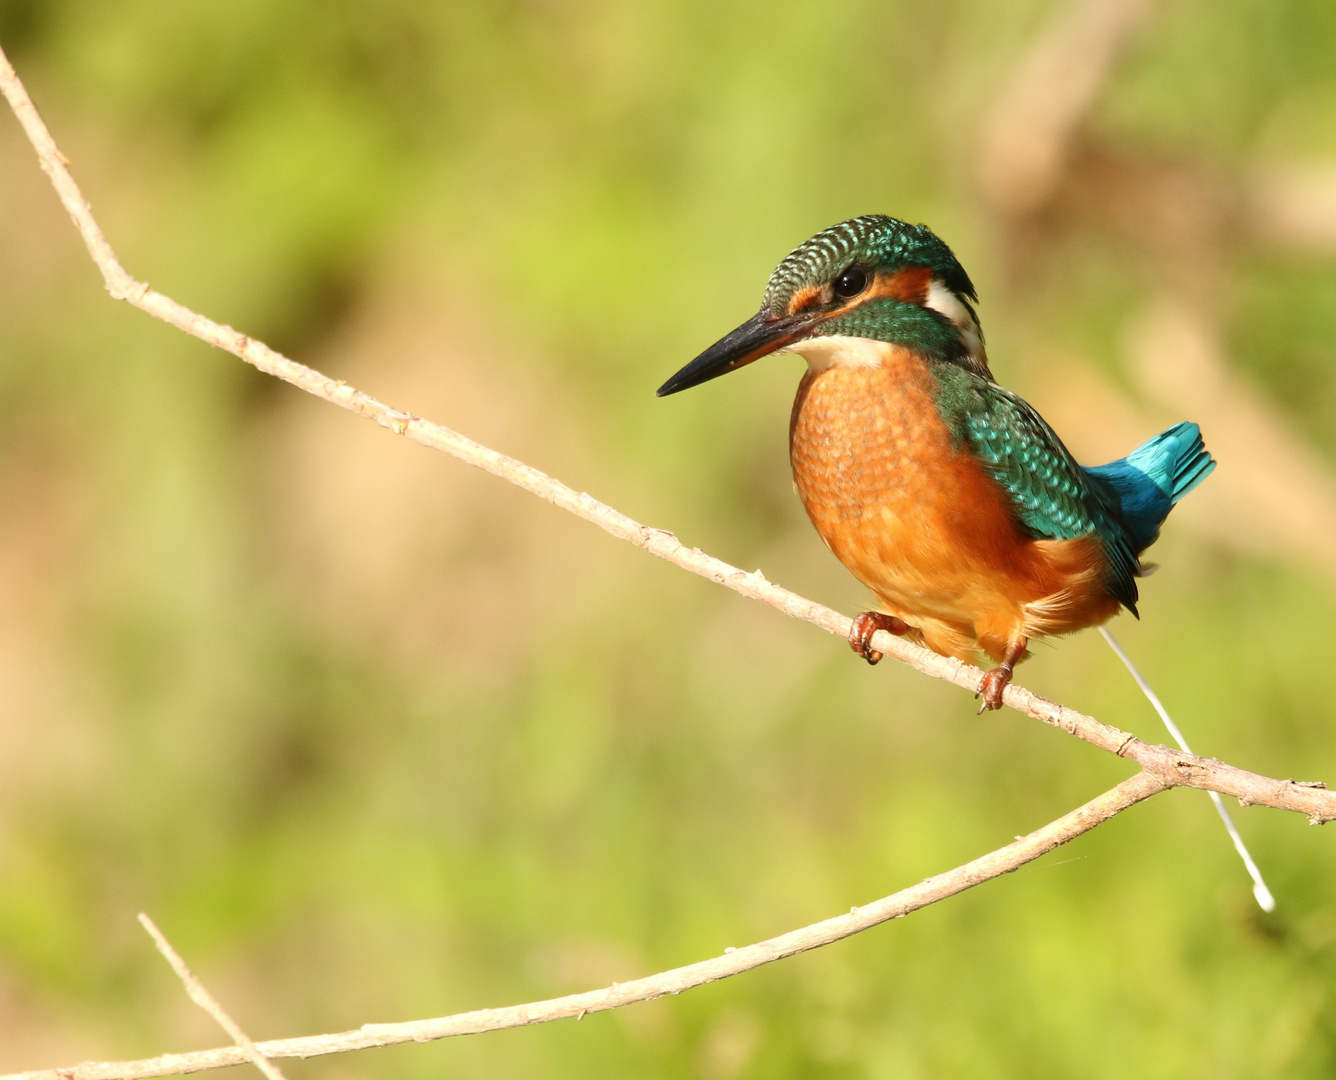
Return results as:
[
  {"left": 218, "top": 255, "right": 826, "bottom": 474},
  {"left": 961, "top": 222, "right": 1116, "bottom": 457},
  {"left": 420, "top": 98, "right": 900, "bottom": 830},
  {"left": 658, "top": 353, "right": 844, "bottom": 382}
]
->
[{"left": 0, "top": 0, "right": 1336, "bottom": 1080}]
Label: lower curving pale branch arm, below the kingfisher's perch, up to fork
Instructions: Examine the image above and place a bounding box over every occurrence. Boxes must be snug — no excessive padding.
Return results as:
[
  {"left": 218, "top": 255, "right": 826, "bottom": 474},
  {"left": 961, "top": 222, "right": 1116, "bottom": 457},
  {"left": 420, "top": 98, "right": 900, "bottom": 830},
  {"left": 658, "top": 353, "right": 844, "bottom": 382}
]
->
[{"left": 0, "top": 771, "right": 1174, "bottom": 1080}]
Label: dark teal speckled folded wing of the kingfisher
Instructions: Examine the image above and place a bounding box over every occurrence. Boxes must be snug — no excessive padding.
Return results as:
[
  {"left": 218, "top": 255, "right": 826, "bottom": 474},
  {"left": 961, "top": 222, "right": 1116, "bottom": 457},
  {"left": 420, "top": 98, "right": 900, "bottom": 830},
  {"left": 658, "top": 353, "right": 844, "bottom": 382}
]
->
[{"left": 957, "top": 380, "right": 1141, "bottom": 614}]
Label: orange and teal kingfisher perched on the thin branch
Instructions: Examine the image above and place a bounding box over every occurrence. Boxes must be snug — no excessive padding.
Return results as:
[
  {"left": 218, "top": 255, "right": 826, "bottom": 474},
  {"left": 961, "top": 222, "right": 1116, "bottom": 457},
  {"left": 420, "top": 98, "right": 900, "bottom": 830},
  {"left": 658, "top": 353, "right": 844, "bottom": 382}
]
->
[{"left": 659, "top": 214, "right": 1216, "bottom": 711}]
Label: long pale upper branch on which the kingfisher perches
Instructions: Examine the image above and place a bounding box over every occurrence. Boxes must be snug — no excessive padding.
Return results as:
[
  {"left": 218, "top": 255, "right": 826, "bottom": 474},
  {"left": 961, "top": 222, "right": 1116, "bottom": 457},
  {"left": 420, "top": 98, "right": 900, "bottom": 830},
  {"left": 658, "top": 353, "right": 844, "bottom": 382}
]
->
[{"left": 0, "top": 40, "right": 1336, "bottom": 825}]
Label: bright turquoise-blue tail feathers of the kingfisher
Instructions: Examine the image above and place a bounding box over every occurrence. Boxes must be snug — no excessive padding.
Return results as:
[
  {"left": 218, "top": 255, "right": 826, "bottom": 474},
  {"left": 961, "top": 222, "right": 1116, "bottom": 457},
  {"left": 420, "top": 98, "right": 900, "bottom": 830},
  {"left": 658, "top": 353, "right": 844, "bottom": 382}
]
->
[{"left": 1086, "top": 422, "right": 1216, "bottom": 555}]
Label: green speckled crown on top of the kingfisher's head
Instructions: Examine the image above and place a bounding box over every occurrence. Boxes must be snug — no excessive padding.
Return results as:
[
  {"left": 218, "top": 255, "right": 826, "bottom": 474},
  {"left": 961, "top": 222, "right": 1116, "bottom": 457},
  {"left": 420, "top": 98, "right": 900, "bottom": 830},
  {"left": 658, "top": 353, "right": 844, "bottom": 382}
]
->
[{"left": 762, "top": 214, "right": 978, "bottom": 314}]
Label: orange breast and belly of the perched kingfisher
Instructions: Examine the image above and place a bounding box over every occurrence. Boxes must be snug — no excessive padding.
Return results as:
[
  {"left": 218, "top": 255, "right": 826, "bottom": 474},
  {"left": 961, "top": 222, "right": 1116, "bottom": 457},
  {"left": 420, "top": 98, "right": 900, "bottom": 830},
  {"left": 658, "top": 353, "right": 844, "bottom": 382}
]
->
[{"left": 790, "top": 345, "right": 1118, "bottom": 660}]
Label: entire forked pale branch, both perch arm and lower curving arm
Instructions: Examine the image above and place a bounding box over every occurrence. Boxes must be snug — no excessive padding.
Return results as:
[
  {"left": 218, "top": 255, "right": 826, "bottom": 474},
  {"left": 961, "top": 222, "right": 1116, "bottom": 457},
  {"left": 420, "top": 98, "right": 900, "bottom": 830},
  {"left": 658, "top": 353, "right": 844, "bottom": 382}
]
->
[{"left": 0, "top": 40, "right": 1336, "bottom": 1080}]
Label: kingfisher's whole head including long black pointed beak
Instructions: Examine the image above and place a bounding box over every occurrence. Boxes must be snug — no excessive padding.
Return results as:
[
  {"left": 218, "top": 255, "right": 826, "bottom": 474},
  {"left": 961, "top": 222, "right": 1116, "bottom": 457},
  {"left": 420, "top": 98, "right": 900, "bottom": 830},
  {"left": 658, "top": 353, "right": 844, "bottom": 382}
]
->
[{"left": 659, "top": 214, "right": 990, "bottom": 397}]
